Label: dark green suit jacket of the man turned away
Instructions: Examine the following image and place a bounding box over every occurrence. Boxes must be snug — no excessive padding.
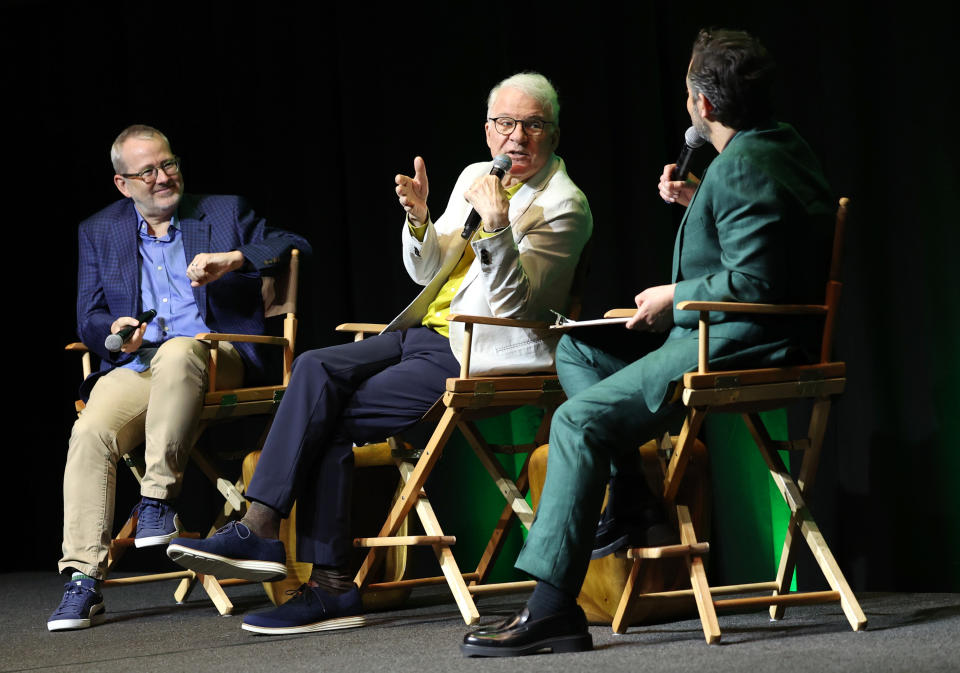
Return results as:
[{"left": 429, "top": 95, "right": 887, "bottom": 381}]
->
[{"left": 639, "top": 122, "right": 835, "bottom": 410}]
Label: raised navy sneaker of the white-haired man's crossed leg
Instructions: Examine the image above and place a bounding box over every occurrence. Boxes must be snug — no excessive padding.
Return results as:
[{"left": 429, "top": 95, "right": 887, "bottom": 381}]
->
[{"left": 167, "top": 521, "right": 287, "bottom": 582}]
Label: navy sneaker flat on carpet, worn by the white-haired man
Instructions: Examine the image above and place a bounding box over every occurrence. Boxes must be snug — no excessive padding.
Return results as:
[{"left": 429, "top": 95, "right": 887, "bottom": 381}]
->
[{"left": 241, "top": 584, "right": 366, "bottom": 636}]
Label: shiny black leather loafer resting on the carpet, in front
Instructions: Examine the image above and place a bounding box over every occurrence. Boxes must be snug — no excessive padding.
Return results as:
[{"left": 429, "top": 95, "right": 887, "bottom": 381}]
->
[{"left": 460, "top": 605, "right": 593, "bottom": 657}]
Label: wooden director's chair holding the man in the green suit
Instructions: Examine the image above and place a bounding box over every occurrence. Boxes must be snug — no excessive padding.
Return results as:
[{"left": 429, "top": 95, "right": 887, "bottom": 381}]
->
[{"left": 608, "top": 198, "right": 867, "bottom": 643}]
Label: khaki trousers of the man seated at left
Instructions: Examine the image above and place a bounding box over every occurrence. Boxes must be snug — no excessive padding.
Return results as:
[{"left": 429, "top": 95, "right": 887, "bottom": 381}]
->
[{"left": 60, "top": 337, "right": 243, "bottom": 579}]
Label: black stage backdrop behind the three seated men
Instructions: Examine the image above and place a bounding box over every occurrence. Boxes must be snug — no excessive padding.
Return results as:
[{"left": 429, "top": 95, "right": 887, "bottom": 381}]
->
[{"left": 0, "top": 0, "right": 960, "bottom": 591}]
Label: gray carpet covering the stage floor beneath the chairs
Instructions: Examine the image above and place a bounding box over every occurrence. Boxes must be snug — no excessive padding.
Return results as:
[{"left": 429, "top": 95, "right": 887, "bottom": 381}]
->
[{"left": 0, "top": 572, "right": 960, "bottom": 673}]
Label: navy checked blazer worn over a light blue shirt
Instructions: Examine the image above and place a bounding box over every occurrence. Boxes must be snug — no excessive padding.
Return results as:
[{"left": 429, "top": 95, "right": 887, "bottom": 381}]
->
[{"left": 77, "top": 194, "right": 311, "bottom": 399}]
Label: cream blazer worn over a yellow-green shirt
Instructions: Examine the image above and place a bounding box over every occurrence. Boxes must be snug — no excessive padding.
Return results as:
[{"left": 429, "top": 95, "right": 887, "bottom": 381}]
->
[{"left": 384, "top": 155, "right": 593, "bottom": 376}]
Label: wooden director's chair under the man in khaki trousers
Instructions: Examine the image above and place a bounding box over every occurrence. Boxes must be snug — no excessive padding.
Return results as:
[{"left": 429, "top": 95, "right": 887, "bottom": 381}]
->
[{"left": 66, "top": 249, "right": 300, "bottom": 615}]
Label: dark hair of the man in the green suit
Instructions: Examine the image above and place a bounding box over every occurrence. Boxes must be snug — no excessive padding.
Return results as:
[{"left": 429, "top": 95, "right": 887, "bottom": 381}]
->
[{"left": 687, "top": 29, "right": 776, "bottom": 129}]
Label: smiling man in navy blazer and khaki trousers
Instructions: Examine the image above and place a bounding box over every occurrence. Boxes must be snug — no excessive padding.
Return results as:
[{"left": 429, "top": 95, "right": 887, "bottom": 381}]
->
[{"left": 47, "top": 125, "right": 310, "bottom": 631}]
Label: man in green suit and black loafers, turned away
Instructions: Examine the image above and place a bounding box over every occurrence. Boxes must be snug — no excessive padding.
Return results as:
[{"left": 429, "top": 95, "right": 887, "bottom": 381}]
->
[{"left": 461, "top": 31, "right": 833, "bottom": 656}]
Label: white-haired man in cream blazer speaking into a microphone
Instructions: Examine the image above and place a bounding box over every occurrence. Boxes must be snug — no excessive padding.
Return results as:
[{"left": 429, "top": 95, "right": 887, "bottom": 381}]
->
[{"left": 167, "top": 73, "right": 592, "bottom": 635}]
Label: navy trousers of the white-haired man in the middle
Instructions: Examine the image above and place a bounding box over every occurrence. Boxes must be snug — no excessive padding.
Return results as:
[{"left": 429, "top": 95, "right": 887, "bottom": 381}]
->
[{"left": 246, "top": 327, "right": 460, "bottom": 566}]
